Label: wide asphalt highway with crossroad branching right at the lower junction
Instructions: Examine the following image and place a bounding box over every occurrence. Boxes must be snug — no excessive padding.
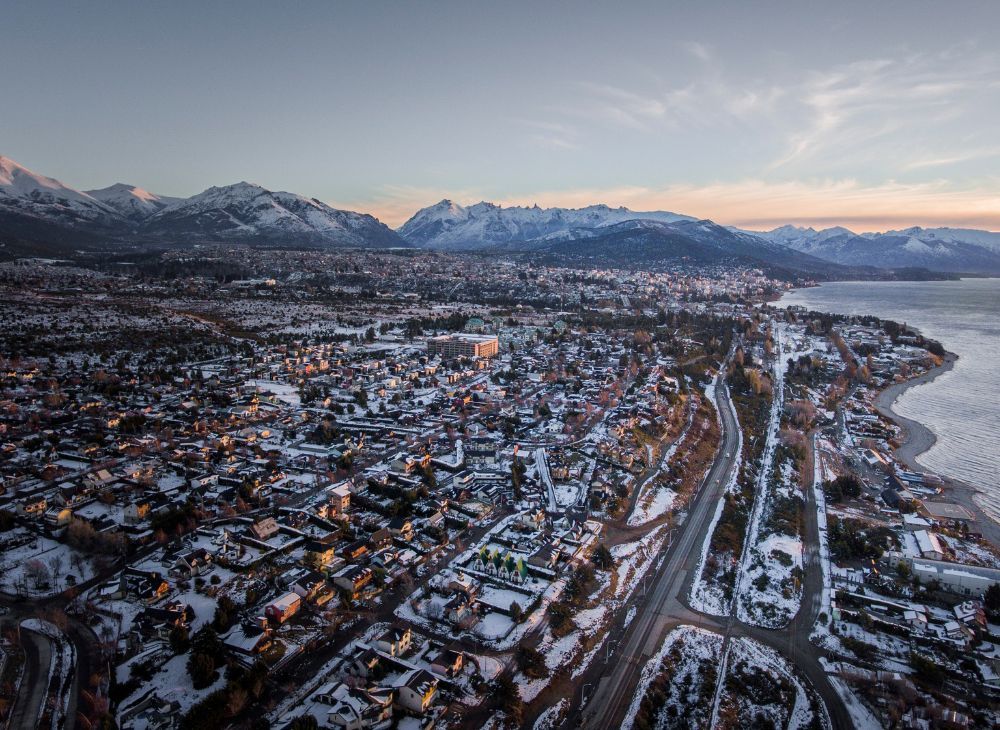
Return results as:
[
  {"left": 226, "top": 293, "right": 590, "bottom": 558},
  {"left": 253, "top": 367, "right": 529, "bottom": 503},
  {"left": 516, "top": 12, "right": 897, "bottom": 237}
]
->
[{"left": 563, "top": 377, "right": 852, "bottom": 729}]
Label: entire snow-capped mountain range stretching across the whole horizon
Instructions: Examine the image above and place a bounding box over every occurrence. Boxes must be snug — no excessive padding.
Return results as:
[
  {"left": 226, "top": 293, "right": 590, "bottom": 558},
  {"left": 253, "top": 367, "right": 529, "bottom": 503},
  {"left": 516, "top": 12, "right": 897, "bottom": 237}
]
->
[{"left": 0, "top": 157, "right": 1000, "bottom": 276}]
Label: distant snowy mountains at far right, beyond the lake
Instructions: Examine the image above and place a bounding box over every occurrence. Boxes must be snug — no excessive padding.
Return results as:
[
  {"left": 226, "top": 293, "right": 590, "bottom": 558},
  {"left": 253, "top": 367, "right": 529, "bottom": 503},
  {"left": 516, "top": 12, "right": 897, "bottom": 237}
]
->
[{"left": 756, "top": 226, "right": 1000, "bottom": 273}]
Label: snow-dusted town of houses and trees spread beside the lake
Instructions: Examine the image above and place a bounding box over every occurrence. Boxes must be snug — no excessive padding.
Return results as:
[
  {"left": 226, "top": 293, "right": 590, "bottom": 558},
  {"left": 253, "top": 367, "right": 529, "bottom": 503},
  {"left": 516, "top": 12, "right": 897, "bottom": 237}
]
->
[{"left": 0, "top": 245, "right": 1000, "bottom": 730}]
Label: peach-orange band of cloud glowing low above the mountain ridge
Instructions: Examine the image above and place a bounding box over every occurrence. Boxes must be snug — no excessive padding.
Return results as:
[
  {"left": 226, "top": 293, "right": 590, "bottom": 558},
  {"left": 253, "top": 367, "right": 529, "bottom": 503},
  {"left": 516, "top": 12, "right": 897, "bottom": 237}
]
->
[{"left": 338, "top": 179, "right": 1000, "bottom": 230}]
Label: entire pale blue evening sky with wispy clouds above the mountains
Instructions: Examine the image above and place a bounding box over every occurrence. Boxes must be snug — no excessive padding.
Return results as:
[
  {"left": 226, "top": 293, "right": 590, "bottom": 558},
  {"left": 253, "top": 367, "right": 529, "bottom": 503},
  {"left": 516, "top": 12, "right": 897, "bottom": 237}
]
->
[{"left": 0, "top": 0, "right": 1000, "bottom": 231}]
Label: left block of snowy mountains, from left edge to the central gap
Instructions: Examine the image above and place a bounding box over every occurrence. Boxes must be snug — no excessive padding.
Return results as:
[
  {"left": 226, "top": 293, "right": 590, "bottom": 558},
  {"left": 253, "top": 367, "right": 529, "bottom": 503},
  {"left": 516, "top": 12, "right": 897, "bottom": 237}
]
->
[{"left": 0, "top": 157, "right": 408, "bottom": 253}]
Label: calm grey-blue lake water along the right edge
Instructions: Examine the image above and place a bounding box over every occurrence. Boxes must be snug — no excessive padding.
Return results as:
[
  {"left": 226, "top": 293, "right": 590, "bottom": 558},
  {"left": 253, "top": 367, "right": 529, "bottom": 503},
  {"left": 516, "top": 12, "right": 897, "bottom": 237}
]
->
[{"left": 780, "top": 279, "right": 1000, "bottom": 518}]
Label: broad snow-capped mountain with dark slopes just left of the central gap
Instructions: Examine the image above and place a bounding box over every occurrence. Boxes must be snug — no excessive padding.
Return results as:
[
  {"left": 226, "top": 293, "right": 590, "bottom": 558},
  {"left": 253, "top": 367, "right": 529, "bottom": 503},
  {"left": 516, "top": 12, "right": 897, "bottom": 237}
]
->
[{"left": 140, "top": 182, "right": 407, "bottom": 247}]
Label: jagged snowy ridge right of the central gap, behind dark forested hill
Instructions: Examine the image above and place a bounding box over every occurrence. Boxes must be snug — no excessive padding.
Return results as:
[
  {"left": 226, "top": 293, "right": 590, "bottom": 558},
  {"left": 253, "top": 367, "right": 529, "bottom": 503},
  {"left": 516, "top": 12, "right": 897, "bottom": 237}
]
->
[{"left": 398, "top": 200, "right": 694, "bottom": 250}]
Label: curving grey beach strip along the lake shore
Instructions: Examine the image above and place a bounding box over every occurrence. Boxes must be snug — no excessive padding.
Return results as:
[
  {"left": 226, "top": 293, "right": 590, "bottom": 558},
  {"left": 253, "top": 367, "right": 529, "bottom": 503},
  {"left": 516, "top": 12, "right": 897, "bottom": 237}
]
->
[{"left": 873, "top": 352, "right": 1000, "bottom": 546}]
